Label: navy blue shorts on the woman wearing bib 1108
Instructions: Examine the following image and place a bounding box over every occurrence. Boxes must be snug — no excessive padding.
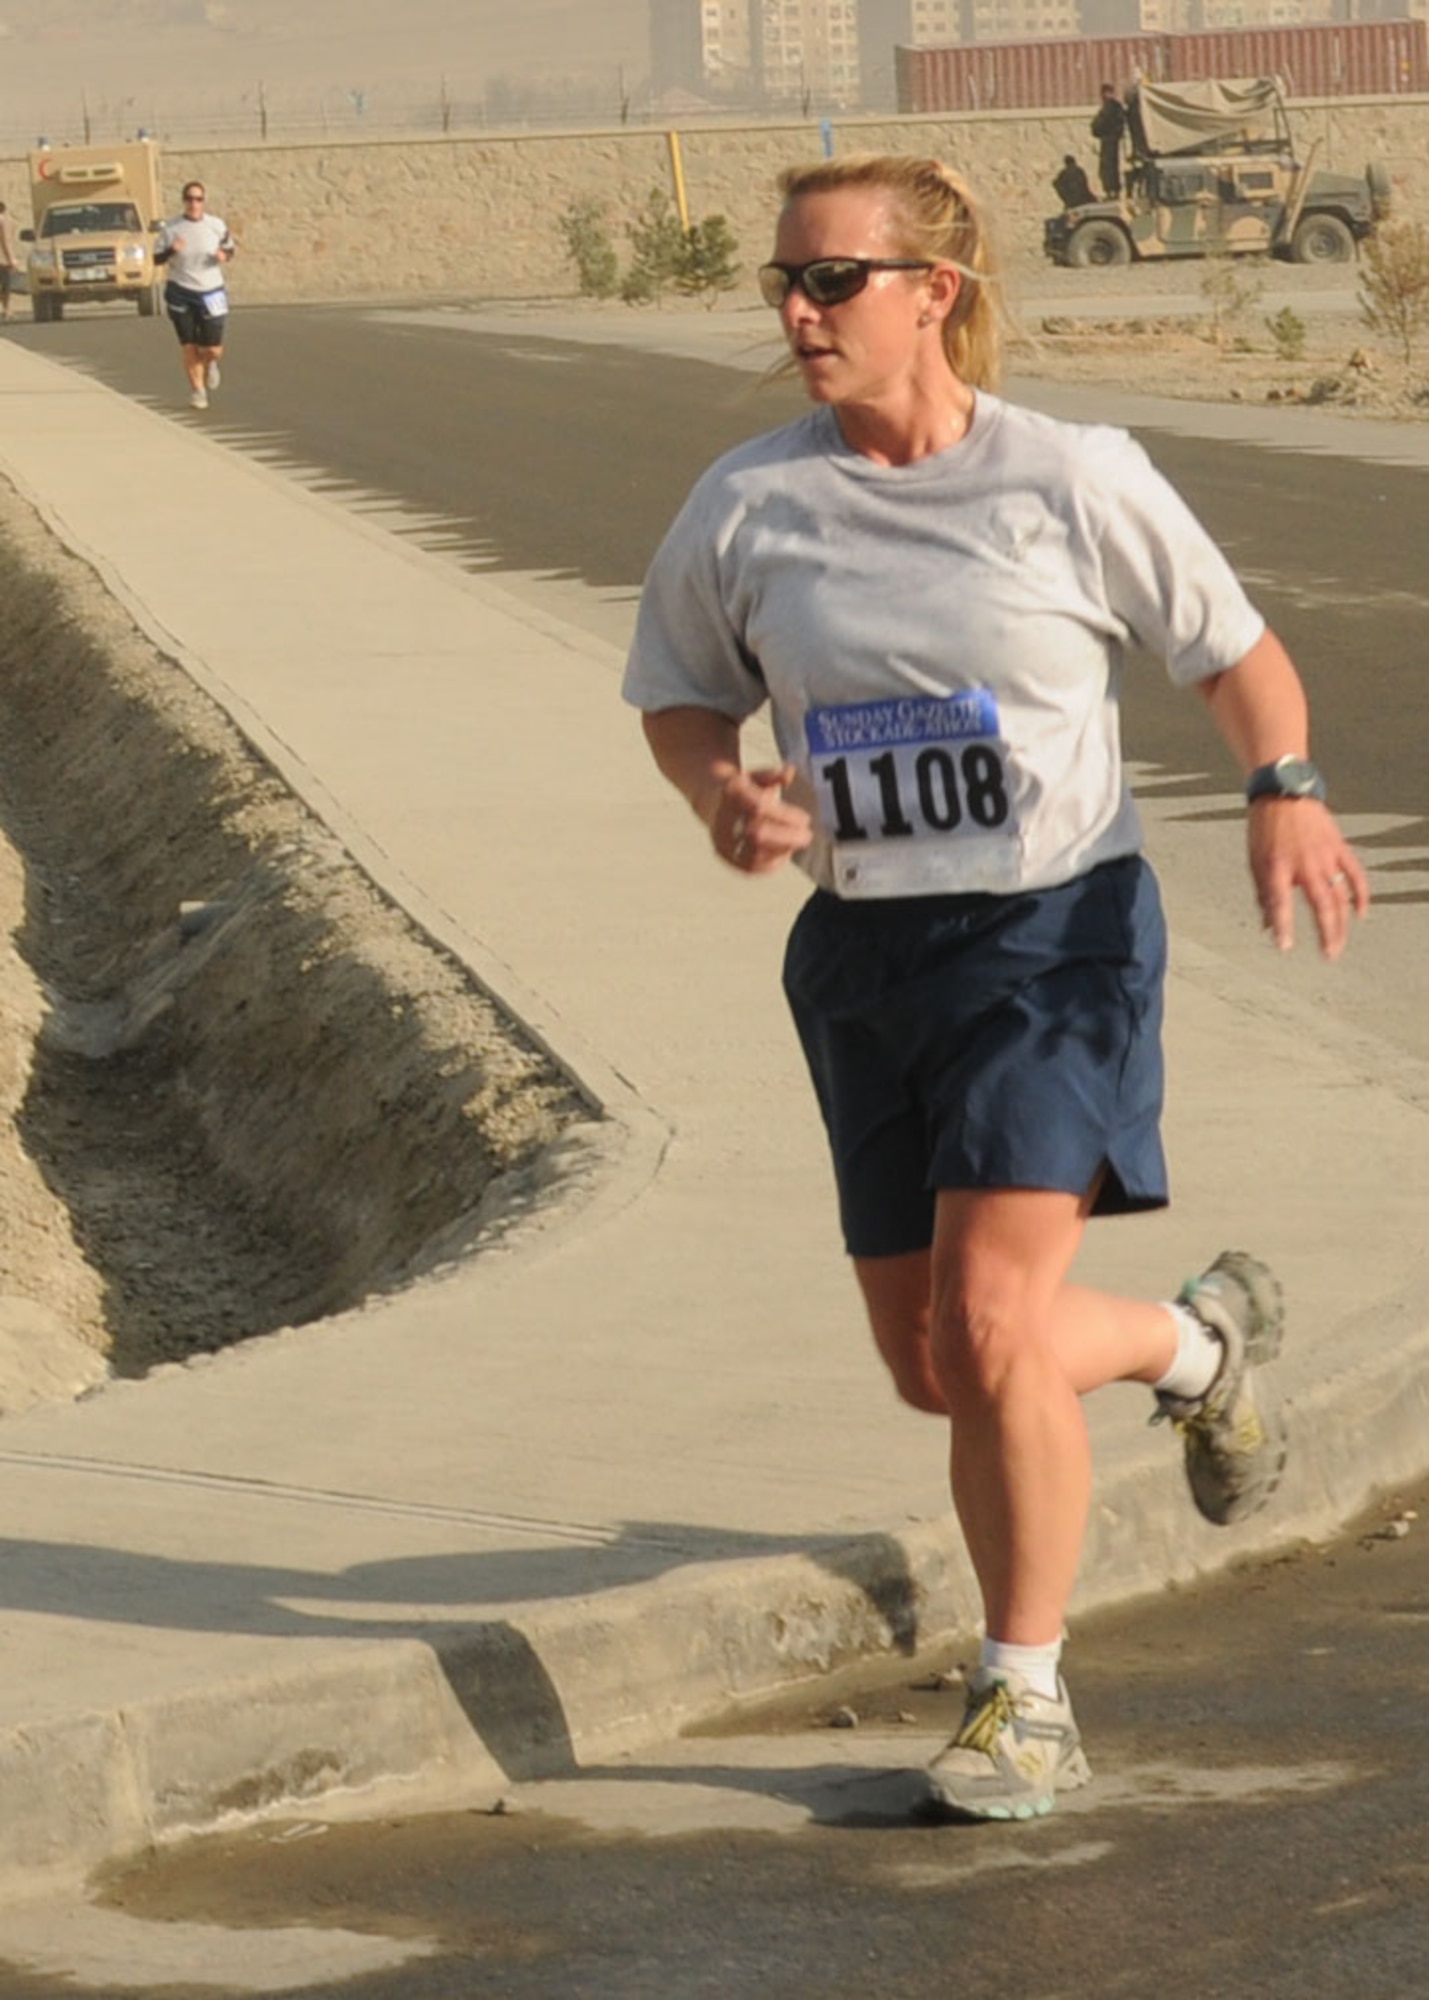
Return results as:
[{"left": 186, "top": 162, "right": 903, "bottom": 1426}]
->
[{"left": 785, "top": 856, "right": 1167, "bottom": 1256}]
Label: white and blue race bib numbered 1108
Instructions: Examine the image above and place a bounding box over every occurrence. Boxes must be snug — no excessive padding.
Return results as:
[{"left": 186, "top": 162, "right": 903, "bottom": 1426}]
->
[{"left": 807, "top": 688, "right": 1019, "bottom": 896}]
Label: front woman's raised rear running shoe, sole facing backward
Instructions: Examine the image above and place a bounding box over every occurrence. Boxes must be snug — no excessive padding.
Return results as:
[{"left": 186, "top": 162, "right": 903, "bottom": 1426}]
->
[{"left": 1153, "top": 1250, "right": 1289, "bottom": 1528}]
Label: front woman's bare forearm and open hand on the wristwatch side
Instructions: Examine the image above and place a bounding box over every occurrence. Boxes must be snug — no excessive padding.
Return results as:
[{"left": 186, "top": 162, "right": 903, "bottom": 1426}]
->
[{"left": 1201, "top": 630, "right": 1369, "bottom": 958}]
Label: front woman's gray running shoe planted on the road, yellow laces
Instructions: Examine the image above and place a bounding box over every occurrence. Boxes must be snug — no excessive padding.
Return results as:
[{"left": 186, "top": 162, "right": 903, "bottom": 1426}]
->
[{"left": 925, "top": 1666, "right": 1091, "bottom": 1820}]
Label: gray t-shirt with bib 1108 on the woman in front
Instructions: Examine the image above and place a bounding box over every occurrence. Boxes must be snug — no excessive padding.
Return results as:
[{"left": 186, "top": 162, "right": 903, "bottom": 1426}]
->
[{"left": 624, "top": 394, "right": 1265, "bottom": 896}]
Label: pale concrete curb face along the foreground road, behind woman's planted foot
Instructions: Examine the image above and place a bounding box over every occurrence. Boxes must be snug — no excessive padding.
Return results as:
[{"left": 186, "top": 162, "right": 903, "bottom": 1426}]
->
[{"left": 11, "top": 1272, "right": 1429, "bottom": 1894}]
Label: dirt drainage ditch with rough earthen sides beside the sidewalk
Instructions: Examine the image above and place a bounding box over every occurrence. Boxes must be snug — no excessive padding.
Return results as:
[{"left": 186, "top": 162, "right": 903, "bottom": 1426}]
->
[{"left": 0, "top": 490, "right": 590, "bottom": 1412}]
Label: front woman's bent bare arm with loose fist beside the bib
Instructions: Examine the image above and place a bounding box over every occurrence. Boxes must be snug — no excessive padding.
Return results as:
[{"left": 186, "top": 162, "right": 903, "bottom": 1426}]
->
[{"left": 642, "top": 708, "right": 813, "bottom": 874}]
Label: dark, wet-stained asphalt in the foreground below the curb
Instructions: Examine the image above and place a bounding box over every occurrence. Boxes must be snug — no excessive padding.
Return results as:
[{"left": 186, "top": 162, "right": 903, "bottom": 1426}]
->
[{"left": 0, "top": 1486, "right": 1429, "bottom": 2000}]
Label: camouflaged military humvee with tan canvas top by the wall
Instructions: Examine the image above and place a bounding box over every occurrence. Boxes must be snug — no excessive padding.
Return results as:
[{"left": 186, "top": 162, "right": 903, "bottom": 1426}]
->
[{"left": 1043, "top": 76, "right": 1389, "bottom": 268}]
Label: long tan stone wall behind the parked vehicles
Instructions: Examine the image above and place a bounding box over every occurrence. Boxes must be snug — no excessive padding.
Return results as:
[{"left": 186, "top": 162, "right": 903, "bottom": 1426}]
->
[{"left": 0, "top": 98, "right": 1429, "bottom": 304}]
